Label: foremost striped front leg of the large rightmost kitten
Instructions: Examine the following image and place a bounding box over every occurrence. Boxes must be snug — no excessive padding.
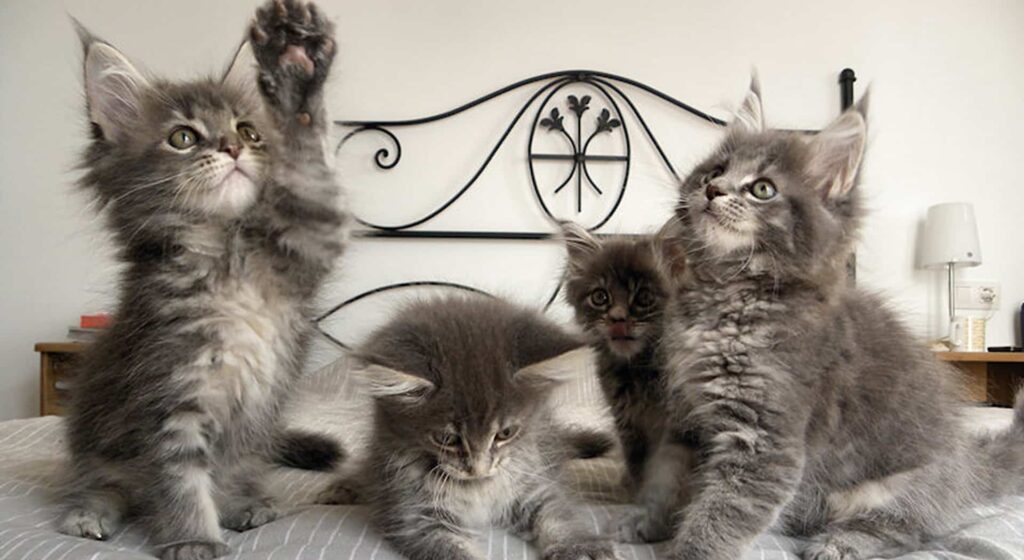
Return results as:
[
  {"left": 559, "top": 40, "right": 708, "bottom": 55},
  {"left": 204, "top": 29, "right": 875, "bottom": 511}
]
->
[{"left": 671, "top": 401, "right": 804, "bottom": 560}]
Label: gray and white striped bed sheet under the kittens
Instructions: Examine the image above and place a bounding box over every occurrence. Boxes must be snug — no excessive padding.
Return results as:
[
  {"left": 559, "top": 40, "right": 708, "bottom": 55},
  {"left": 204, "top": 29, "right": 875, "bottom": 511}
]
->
[{"left": 0, "top": 356, "right": 1024, "bottom": 560}]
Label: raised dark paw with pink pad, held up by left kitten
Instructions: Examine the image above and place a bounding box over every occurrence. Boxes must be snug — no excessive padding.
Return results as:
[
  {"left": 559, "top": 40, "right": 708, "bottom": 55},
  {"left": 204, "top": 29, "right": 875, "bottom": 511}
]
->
[{"left": 249, "top": 0, "right": 335, "bottom": 121}]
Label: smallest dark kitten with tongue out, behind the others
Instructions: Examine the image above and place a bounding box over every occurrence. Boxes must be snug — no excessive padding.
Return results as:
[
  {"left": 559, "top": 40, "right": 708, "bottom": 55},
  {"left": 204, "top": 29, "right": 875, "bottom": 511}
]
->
[{"left": 562, "top": 222, "right": 683, "bottom": 490}]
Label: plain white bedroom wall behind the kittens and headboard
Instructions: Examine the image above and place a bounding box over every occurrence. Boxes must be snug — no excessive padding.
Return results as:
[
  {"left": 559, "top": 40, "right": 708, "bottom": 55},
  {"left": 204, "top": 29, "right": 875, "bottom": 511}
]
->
[{"left": 0, "top": 0, "right": 1024, "bottom": 419}]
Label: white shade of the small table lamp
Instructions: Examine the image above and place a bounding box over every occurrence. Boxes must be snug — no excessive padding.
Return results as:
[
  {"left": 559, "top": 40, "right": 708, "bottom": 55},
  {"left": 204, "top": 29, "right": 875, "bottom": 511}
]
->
[{"left": 921, "top": 203, "right": 981, "bottom": 267}]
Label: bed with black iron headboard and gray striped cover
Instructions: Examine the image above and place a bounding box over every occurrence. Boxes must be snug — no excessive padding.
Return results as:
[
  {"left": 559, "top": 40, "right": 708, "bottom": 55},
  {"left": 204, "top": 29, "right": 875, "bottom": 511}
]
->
[{"left": 0, "top": 69, "right": 1024, "bottom": 560}]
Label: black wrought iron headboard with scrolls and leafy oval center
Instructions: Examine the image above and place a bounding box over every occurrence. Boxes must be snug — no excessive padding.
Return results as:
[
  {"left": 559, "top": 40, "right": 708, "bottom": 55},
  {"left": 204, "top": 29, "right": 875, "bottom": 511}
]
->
[{"left": 315, "top": 69, "right": 856, "bottom": 349}]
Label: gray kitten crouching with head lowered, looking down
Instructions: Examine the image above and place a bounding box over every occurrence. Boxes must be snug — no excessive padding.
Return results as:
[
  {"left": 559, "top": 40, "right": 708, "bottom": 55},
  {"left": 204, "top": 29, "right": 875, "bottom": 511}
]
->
[{"left": 328, "top": 296, "right": 617, "bottom": 560}]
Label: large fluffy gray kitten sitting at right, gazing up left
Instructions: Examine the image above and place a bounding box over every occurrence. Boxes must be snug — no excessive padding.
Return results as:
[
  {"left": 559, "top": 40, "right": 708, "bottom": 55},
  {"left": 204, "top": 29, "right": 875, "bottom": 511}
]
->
[{"left": 622, "top": 80, "right": 1024, "bottom": 560}]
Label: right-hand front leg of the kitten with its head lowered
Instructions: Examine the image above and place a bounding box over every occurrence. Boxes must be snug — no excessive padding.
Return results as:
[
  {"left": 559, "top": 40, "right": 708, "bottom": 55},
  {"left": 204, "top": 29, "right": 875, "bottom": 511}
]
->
[{"left": 513, "top": 484, "right": 620, "bottom": 560}]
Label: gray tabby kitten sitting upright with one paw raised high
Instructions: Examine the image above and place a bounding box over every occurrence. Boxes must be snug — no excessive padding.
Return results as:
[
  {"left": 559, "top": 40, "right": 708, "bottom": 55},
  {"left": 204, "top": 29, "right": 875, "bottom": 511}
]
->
[{"left": 59, "top": 1, "right": 347, "bottom": 560}]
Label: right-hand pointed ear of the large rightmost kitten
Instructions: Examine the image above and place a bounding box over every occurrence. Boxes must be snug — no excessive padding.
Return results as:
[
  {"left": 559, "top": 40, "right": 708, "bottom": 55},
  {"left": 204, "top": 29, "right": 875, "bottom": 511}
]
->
[{"left": 808, "top": 99, "right": 867, "bottom": 199}]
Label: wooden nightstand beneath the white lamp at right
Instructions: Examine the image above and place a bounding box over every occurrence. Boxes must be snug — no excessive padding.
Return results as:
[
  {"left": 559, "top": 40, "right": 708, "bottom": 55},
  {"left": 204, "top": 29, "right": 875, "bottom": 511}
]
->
[{"left": 935, "top": 352, "right": 1024, "bottom": 406}]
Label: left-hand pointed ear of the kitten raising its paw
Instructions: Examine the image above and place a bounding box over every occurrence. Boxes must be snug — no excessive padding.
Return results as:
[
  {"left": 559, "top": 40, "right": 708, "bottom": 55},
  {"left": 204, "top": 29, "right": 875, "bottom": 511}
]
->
[{"left": 75, "top": 21, "right": 151, "bottom": 140}]
